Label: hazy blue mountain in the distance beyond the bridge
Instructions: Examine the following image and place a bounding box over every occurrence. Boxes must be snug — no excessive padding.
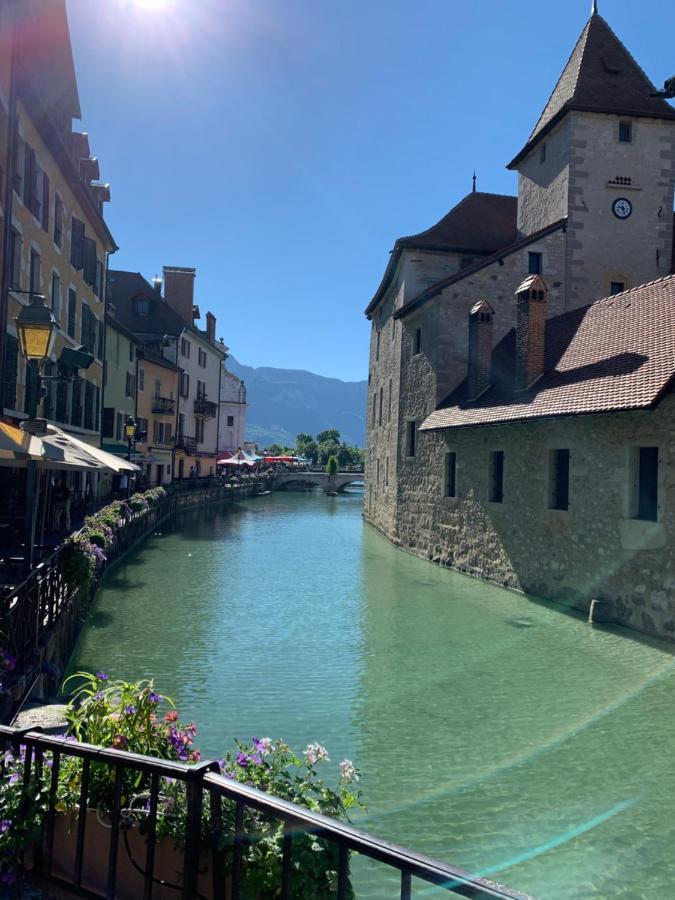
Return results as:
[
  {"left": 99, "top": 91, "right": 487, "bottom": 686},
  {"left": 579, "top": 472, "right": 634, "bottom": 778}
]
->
[{"left": 227, "top": 356, "right": 367, "bottom": 447}]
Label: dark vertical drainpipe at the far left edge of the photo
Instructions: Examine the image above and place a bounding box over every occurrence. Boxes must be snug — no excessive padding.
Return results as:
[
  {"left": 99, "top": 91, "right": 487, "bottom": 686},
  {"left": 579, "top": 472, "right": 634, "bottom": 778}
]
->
[{"left": 0, "top": 0, "right": 19, "bottom": 419}]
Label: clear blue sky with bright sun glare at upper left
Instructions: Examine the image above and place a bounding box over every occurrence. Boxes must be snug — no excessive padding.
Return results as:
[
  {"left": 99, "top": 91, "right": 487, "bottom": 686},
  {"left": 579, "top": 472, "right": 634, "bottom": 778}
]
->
[{"left": 67, "top": 0, "right": 675, "bottom": 381}]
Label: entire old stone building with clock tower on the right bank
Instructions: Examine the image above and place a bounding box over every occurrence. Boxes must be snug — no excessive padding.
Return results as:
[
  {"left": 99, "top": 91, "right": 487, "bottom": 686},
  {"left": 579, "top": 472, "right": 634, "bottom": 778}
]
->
[{"left": 365, "top": 13, "right": 675, "bottom": 634}]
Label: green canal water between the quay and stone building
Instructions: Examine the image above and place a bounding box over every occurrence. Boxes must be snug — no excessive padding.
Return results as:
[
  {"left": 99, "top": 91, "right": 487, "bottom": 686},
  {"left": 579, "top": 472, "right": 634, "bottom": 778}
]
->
[{"left": 71, "top": 492, "right": 675, "bottom": 900}]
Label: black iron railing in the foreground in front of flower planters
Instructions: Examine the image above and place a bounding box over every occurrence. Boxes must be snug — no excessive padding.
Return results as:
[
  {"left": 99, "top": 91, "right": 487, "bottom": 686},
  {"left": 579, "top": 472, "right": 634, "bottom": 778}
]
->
[{"left": 0, "top": 727, "right": 527, "bottom": 900}]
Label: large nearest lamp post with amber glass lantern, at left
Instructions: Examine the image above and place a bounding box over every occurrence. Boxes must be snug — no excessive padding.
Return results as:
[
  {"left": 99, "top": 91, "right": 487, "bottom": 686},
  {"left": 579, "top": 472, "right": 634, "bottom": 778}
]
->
[{"left": 14, "top": 292, "right": 58, "bottom": 575}]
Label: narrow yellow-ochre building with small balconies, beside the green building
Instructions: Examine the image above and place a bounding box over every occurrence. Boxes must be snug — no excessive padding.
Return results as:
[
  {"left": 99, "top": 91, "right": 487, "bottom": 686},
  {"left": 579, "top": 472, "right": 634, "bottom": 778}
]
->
[{"left": 132, "top": 348, "right": 180, "bottom": 487}]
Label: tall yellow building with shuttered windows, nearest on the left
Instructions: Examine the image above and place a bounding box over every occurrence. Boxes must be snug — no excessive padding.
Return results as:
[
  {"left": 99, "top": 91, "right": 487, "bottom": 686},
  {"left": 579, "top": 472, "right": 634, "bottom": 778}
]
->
[{"left": 0, "top": 0, "right": 117, "bottom": 460}]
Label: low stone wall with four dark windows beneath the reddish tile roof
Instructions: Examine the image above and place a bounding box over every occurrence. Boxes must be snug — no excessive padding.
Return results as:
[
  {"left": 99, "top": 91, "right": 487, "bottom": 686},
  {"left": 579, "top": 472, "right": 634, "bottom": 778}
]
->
[{"left": 390, "top": 395, "right": 675, "bottom": 639}]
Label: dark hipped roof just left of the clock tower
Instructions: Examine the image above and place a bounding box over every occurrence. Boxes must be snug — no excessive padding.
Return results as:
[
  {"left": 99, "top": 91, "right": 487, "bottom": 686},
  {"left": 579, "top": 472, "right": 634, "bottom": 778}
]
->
[{"left": 366, "top": 191, "right": 518, "bottom": 315}]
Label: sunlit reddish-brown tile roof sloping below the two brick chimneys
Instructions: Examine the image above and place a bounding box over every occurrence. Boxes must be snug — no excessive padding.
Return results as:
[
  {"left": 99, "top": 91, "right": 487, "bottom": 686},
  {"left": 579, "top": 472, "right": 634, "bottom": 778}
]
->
[{"left": 421, "top": 275, "right": 675, "bottom": 431}]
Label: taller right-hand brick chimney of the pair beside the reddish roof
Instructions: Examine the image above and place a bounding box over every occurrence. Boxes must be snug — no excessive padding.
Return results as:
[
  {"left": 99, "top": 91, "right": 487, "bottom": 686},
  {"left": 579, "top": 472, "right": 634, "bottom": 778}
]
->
[{"left": 516, "top": 275, "right": 548, "bottom": 391}]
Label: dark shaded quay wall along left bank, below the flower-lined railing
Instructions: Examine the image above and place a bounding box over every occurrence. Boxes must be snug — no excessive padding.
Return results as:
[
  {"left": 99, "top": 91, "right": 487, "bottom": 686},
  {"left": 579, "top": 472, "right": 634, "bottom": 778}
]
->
[{"left": 0, "top": 478, "right": 266, "bottom": 724}]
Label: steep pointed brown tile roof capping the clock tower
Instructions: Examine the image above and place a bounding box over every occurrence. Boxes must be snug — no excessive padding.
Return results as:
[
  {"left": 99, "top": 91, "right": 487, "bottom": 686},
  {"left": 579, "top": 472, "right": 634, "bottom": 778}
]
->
[{"left": 509, "top": 14, "right": 675, "bottom": 168}]
